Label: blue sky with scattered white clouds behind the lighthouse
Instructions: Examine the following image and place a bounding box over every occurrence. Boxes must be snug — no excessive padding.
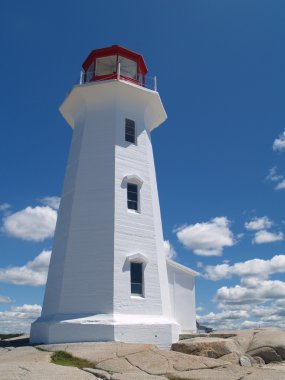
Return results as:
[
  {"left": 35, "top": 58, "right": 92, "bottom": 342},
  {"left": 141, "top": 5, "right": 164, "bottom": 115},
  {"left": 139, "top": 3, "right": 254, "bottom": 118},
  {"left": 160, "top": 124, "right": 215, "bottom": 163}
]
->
[{"left": 0, "top": 0, "right": 285, "bottom": 331}]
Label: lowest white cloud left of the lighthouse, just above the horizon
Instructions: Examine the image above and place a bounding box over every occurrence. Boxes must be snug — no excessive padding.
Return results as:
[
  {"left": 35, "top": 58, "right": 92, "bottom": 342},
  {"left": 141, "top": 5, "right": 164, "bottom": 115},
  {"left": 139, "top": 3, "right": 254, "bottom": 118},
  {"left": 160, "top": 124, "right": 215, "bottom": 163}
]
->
[{"left": 0, "top": 304, "right": 42, "bottom": 333}]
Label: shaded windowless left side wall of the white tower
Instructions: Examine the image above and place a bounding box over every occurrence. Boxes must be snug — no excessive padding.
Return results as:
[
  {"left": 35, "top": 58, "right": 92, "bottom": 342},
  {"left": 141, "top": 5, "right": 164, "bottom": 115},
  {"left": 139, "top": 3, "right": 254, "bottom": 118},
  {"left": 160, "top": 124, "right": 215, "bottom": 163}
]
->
[{"left": 42, "top": 89, "right": 116, "bottom": 317}]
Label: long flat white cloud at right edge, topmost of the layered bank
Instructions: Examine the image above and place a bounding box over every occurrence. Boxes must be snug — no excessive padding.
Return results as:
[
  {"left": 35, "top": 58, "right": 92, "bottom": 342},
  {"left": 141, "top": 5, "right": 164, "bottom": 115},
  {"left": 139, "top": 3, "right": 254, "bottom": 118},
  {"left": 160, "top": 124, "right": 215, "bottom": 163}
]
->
[{"left": 204, "top": 255, "right": 285, "bottom": 281}]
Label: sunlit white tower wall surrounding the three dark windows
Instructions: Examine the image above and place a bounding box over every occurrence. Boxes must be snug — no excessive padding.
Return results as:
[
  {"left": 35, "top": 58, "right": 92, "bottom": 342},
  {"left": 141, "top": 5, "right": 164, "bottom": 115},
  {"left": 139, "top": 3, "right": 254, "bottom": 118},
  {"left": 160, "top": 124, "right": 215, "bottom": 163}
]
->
[{"left": 114, "top": 86, "right": 170, "bottom": 316}]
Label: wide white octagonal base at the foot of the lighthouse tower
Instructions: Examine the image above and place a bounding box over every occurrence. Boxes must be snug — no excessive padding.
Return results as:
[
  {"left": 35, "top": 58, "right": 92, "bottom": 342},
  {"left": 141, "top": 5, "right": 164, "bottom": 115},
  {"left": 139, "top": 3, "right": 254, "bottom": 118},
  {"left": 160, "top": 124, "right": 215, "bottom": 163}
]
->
[{"left": 30, "top": 314, "right": 180, "bottom": 349}]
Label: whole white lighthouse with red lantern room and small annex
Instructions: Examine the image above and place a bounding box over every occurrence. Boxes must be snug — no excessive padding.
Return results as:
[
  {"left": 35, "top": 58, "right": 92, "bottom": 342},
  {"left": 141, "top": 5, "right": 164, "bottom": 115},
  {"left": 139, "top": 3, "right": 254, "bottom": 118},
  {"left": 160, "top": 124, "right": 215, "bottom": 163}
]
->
[{"left": 31, "top": 45, "right": 197, "bottom": 347}]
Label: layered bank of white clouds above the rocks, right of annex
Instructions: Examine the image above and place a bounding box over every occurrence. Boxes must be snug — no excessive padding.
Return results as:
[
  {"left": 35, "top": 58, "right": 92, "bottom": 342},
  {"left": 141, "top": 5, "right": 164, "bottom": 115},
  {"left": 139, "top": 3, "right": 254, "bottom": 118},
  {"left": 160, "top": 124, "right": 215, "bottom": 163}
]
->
[{"left": 199, "top": 255, "right": 285, "bottom": 330}]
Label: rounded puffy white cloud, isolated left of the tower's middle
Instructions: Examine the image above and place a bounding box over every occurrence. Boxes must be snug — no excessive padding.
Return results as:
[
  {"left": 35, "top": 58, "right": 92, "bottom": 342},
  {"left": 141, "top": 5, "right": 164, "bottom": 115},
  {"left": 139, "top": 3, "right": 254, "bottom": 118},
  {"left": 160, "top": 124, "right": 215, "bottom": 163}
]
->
[{"left": 2, "top": 206, "right": 57, "bottom": 241}]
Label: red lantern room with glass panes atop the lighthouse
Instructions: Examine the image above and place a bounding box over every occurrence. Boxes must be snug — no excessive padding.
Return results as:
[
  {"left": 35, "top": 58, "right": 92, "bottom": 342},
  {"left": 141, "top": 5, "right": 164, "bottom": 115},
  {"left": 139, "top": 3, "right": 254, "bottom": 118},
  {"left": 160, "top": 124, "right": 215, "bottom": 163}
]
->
[{"left": 82, "top": 45, "right": 147, "bottom": 86}]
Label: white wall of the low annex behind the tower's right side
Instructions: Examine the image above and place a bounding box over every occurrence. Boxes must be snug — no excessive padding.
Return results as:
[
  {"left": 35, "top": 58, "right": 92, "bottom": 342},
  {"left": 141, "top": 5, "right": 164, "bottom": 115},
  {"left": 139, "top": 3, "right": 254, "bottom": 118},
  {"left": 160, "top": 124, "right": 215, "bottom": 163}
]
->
[{"left": 167, "top": 260, "right": 198, "bottom": 332}]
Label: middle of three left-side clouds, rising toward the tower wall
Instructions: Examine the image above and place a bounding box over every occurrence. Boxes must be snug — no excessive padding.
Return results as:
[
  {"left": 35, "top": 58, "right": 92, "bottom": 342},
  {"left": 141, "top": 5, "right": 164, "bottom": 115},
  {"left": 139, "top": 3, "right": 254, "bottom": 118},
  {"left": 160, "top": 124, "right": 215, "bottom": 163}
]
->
[{"left": 0, "top": 251, "right": 51, "bottom": 286}]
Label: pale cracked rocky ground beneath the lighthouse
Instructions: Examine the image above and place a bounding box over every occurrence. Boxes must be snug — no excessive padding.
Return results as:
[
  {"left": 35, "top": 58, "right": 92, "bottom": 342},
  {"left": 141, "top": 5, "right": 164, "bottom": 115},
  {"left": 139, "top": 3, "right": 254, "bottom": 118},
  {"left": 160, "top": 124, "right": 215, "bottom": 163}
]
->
[{"left": 0, "top": 329, "right": 285, "bottom": 380}]
